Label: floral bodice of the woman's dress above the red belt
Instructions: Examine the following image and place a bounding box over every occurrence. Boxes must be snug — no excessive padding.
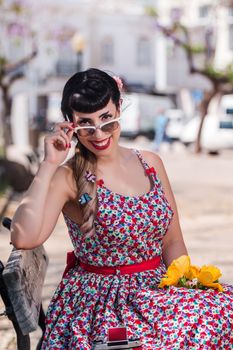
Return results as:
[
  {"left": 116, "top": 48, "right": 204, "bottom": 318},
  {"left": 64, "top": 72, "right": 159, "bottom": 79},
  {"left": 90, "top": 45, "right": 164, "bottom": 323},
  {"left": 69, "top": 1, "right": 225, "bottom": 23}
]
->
[{"left": 64, "top": 151, "right": 173, "bottom": 266}]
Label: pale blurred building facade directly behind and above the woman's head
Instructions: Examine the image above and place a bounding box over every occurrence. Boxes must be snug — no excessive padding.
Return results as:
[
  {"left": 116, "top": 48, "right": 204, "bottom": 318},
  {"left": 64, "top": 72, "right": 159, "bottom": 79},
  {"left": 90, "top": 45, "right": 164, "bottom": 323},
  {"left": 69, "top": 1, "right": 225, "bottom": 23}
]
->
[{"left": 26, "top": 0, "right": 158, "bottom": 86}]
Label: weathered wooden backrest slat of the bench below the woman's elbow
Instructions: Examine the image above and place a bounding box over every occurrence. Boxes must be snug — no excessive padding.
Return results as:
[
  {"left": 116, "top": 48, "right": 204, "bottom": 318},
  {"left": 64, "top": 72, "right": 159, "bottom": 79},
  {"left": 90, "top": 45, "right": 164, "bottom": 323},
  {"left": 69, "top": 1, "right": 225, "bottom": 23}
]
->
[{"left": 3, "top": 246, "right": 48, "bottom": 335}]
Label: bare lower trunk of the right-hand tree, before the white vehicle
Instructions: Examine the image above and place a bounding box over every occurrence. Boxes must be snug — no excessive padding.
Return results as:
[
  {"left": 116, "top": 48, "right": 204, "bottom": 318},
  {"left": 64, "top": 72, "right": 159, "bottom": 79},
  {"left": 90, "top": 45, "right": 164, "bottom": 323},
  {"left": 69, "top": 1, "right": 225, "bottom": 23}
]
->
[{"left": 194, "top": 89, "right": 218, "bottom": 154}]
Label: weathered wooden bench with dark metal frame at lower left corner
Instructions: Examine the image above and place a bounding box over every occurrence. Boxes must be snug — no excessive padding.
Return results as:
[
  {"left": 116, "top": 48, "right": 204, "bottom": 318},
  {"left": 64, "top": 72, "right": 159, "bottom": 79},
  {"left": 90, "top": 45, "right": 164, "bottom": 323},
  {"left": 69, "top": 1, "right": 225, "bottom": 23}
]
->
[{"left": 0, "top": 218, "right": 48, "bottom": 350}]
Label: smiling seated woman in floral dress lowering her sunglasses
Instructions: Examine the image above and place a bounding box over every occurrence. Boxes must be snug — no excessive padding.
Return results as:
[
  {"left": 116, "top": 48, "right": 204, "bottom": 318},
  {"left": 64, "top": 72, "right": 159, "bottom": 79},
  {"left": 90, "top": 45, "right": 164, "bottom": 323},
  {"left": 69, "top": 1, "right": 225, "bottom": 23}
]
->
[{"left": 12, "top": 69, "right": 233, "bottom": 350}]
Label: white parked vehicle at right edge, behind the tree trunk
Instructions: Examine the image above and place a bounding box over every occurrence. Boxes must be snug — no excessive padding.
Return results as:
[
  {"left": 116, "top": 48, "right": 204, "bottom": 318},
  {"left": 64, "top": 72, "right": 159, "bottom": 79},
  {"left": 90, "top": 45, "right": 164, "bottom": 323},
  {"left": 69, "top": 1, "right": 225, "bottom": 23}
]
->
[{"left": 180, "top": 95, "right": 233, "bottom": 153}]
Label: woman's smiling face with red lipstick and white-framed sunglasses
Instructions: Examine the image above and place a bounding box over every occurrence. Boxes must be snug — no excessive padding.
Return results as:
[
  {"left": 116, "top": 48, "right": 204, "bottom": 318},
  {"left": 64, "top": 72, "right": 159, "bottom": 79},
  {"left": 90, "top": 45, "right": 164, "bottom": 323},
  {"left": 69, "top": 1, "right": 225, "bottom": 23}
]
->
[{"left": 73, "top": 100, "right": 120, "bottom": 156}]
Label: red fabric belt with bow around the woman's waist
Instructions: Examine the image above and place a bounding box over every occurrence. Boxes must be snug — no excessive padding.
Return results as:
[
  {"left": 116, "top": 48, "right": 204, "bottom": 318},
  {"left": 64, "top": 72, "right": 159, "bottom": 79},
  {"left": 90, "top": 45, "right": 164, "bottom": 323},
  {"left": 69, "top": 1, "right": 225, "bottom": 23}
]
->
[{"left": 63, "top": 252, "right": 161, "bottom": 276}]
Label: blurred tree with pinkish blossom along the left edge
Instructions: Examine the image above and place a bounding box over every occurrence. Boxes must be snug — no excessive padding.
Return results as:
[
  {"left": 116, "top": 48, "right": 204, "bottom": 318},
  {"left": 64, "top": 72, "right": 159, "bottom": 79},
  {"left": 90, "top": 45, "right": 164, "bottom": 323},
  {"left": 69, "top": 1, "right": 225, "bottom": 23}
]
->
[{"left": 0, "top": 0, "right": 37, "bottom": 156}]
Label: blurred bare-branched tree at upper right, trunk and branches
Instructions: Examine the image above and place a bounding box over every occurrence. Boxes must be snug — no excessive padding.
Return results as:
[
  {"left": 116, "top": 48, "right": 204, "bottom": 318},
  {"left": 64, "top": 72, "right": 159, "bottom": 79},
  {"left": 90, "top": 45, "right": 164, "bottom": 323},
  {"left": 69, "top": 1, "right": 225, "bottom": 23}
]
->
[{"left": 147, "top": 1, "right": 233, "bottom": 153}]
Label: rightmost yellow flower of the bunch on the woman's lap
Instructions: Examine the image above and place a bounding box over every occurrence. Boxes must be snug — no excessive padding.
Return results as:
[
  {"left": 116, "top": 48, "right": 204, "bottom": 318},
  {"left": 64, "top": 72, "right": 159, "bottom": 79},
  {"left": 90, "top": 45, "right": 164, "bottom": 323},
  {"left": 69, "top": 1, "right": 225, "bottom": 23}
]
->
[{"left": 197, "top": 265, "right": 223, "bottom": 292}]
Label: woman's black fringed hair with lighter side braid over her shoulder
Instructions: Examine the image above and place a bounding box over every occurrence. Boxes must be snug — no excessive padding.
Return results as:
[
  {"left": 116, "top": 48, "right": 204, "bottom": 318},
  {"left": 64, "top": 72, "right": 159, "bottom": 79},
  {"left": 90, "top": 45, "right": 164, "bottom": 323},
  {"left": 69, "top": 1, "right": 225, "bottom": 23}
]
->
[{"left": 61, "top": 68, "right": 120, "bottom": 237}]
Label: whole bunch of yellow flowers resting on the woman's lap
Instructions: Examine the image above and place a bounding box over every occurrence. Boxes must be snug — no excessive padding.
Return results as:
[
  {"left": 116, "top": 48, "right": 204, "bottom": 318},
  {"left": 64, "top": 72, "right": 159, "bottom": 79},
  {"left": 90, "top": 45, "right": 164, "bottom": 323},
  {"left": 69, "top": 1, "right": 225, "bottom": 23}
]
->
[{"left": 158, "top": 255, "right": 223, "bottom": 292}]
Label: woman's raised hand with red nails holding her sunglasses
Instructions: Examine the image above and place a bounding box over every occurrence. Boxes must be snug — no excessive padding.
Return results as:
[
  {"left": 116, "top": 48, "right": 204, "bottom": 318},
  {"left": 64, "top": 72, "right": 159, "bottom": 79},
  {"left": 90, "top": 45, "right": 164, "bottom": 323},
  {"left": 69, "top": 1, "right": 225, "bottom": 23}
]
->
[{"left": 44, "top": 122, "right": 74, "bottom": 165}]
